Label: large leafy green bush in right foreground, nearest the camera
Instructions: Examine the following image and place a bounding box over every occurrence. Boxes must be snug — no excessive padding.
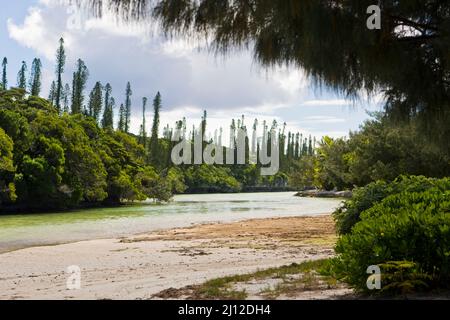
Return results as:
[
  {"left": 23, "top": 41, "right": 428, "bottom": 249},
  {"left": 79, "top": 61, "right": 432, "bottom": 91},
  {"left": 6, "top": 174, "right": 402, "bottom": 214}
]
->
[{"left": 333, "top": 188, "right": 450, "bottom": 292}]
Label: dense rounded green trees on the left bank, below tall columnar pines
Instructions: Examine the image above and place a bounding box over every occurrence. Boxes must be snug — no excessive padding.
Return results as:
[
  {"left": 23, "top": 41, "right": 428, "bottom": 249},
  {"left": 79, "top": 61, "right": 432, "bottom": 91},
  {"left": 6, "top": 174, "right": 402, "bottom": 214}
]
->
[{"left": 0, "top": 89, "right": 172, "bottom": 209}]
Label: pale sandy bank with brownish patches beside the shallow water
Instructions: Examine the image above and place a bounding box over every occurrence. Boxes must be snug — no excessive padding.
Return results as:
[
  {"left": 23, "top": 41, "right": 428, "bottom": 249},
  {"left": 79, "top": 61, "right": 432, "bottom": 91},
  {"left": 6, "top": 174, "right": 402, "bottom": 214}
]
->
[{"left": 0, "top": 216, "right": 336, "bottom": 299}]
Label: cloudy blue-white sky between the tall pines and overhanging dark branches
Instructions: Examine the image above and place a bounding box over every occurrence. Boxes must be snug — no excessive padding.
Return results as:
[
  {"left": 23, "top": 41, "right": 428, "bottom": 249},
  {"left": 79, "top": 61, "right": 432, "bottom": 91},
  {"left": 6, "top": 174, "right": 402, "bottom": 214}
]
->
[{"left": 0, "top": 0, "right": 381, "bottom": 142}]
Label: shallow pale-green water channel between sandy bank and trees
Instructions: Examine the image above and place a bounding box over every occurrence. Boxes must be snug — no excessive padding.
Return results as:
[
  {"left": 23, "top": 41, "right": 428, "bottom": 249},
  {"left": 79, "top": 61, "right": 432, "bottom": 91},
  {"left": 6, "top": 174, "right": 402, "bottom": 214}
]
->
[{"left": 0, "top": 192, "right": 341, "bottom": 252}]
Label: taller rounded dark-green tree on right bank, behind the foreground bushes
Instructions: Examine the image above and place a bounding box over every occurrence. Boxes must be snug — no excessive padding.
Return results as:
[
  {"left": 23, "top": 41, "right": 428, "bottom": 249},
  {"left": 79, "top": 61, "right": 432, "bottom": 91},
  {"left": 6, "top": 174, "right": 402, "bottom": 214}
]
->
[{"left": 344, "top": 116, "right": 450, "bottom": 186}]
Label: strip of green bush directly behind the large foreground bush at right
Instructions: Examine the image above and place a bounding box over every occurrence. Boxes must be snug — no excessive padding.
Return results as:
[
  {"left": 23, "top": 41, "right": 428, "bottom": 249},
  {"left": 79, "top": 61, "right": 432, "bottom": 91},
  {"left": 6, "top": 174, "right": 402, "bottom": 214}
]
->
[{"left": 333, "top": 176, "right": 450, "bottom": 235}]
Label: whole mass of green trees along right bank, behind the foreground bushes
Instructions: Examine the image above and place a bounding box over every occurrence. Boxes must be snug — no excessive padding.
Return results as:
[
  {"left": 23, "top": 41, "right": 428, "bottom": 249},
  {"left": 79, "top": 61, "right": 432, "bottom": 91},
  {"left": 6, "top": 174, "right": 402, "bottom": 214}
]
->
[{"left": 291, "top": 114, "right": 450, "bottom": 190}]
